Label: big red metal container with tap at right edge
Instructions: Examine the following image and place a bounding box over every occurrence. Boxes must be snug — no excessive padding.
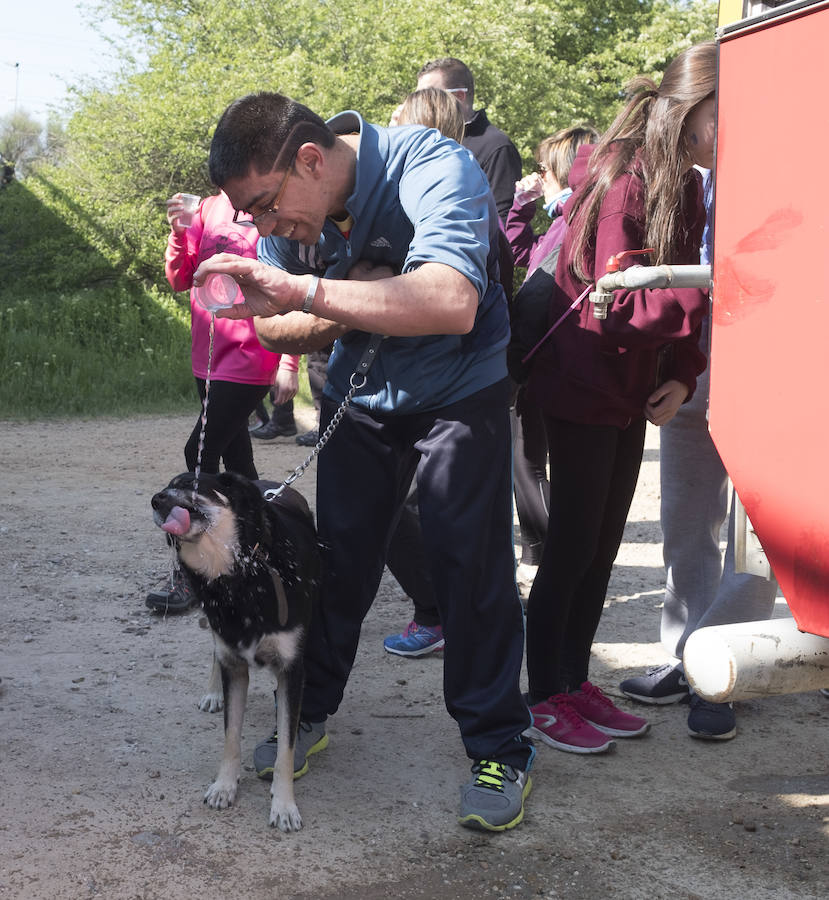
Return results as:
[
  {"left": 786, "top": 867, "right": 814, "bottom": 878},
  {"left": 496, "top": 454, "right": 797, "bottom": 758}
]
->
[{"left": 710, "top": 3, "right": 829, "bottom": 637}]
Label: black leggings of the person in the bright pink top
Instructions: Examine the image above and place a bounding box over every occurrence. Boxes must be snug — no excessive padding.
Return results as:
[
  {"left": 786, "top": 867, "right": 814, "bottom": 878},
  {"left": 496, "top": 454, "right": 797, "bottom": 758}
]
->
[{"left": 184, "top": 378, "right": 268, "bottom": 479}]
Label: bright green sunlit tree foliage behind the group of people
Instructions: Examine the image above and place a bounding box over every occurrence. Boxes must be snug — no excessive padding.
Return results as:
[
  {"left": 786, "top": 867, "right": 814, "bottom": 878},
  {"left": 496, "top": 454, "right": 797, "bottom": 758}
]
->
[{"left": 25, "top": 0, "right": 716, "bottom": 279}]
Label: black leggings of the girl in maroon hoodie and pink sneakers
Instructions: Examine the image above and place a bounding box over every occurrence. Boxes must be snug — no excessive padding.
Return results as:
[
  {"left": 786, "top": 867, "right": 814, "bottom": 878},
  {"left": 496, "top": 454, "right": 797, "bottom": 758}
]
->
[{"left": 527, "top": 416, "right": 645, "bottom": 705}]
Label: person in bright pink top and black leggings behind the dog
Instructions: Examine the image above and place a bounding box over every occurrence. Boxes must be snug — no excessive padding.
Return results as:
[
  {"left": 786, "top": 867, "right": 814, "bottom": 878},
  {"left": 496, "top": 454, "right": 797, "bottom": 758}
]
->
[{"left": 147, "top": 193, "right": 299, "bottom": 612}]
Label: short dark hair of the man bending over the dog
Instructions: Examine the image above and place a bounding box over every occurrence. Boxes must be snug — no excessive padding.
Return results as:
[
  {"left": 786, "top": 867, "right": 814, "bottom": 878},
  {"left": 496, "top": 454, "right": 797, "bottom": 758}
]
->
[{"left": 208, "top": 91, "right": 336, "bottom": 187}]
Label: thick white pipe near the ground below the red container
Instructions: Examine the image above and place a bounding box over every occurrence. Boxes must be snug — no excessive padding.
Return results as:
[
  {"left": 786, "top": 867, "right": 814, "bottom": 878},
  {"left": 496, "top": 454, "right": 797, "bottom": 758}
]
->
[{"left": 682, "top": 618, "right": 829, "bottom": 703}]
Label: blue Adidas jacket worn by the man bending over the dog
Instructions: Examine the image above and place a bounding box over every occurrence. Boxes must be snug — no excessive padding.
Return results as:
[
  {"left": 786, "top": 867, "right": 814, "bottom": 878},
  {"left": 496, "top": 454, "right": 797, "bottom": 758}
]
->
[{"left": 258, "top": 111, "right": 509, "bottom": 414}]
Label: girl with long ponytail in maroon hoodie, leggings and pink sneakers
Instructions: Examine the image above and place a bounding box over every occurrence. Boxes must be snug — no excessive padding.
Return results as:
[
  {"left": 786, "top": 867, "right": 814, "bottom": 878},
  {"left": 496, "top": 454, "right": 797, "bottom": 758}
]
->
[{"left": 527, "top": 42, "right": 717, "bottom": 753}]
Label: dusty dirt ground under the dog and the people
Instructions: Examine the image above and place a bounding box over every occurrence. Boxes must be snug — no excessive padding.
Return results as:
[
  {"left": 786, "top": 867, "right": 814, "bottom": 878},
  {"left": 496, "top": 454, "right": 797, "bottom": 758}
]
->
[{"left": 0, "top": 417, "right": 829, "bottom": 900}]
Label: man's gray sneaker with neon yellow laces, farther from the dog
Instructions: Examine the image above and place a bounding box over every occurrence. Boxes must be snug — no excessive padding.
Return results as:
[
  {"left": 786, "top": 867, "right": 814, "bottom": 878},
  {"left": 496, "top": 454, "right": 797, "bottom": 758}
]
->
[{"left": 458, "top": 759, "right": 532, "bottom": 831}]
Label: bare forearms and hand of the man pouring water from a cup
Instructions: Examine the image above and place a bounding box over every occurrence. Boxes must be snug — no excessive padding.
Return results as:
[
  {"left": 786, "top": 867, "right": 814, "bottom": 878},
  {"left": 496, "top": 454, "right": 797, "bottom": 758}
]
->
[{"left": 193, "top": 253, "right": 478, "bottom": 340}]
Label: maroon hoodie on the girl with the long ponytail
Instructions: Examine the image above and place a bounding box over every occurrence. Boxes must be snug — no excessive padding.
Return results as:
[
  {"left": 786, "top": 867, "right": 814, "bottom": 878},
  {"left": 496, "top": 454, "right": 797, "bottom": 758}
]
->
[{"left": 527, "top": 146, "right": 708, "bottom": 428}]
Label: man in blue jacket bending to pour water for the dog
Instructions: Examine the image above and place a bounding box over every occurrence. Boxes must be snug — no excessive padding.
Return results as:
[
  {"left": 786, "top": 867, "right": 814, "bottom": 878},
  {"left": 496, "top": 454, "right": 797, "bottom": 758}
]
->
[{"left": 195, "top": 94, "right": 534, "bottom": 831}]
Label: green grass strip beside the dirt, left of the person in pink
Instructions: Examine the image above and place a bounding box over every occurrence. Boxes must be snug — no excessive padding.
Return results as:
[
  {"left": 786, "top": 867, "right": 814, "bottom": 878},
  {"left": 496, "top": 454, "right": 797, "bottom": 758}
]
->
[{"left": 0, "top": 282, "right": 195, "bottom": 419}]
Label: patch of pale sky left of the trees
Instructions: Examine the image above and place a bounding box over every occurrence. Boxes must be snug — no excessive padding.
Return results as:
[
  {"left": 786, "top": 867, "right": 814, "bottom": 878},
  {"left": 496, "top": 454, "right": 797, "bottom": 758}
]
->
[{"left": 0, "top": 0, "right": 122, "bottom": 122}]
